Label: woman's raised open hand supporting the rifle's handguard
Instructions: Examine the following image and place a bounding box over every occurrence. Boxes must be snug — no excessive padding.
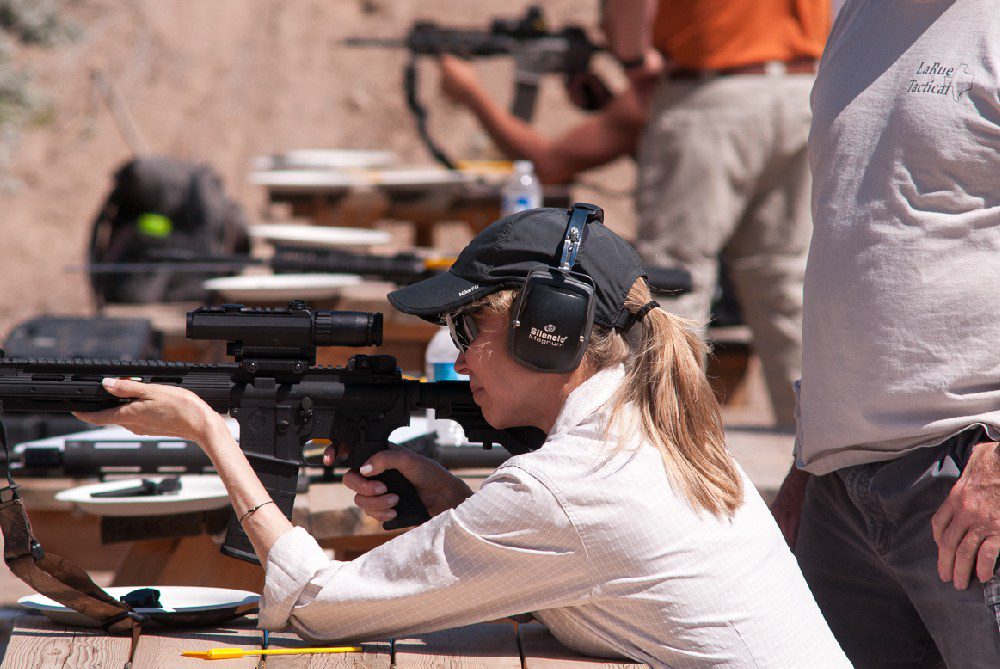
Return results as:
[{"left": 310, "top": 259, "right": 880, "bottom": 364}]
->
[{"left": 73, "top": 379, "right": 222, "bottom": 445}]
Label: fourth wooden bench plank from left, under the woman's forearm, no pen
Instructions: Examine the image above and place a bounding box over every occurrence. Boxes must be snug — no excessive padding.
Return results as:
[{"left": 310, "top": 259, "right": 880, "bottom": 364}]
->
[{"left": 394, "top": 623, "right": 521, "bottom": 669}]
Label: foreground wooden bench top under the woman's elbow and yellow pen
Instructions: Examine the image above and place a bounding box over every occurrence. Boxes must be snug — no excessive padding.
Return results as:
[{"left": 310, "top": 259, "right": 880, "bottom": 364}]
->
[{"left": 0, "top": 615, "right": 649, "bottom": 669}]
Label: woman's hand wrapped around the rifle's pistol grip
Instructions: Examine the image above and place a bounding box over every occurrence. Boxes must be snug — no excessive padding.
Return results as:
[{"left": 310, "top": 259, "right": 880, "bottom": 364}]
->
[{"left": 323, "top": 444, "right": 472, "bottom": 523}]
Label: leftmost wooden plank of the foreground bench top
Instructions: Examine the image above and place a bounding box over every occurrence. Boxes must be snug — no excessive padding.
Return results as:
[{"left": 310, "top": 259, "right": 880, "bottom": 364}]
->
[{"left": 2, "top": 614, "right": 131, "bottom": 669}]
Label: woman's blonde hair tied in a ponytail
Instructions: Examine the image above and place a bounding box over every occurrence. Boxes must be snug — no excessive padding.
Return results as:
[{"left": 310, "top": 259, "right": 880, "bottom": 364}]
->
[{"left": 470, "top": 278, "right": 743, "bottom": 516}]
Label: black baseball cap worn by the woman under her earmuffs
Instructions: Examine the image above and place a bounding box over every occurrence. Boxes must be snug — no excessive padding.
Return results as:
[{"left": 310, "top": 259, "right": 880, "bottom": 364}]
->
[{"left": 388, "top": 208, "right": 646, "bottom": 329}]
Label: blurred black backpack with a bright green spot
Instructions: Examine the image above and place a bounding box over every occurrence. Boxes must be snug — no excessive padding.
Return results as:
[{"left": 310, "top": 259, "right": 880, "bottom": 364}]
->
[{"left": 88, "top": 156, "right": 250, "bottom": 305}]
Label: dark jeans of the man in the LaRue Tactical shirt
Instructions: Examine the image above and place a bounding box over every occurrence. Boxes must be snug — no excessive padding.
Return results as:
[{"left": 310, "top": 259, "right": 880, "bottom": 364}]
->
[{"left": 795, "top": 426, "right": 1000, "bottom": 669}]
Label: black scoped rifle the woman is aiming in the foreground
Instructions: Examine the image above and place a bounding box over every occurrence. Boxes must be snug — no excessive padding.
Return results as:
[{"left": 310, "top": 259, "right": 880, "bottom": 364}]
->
[{"left": 0, "top": 302, "right": 544, "bottom": 562}]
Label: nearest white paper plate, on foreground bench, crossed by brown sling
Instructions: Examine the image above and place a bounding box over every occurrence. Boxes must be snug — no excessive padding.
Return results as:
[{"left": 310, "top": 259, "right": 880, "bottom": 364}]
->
[{"left": 17, "top": 585, "right": 260, "bottom": 627}]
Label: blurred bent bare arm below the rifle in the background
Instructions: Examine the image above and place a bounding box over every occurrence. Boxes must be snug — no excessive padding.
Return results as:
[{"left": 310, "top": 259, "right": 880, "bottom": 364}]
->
[{"left": 440, "top": 56, "right": 647, "bottom": 184}]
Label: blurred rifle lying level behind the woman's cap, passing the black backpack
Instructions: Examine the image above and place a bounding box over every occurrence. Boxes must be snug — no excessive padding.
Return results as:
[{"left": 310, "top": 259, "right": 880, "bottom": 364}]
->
[{"left": 78, "top": 246, "right": 691, "bottom": 297}]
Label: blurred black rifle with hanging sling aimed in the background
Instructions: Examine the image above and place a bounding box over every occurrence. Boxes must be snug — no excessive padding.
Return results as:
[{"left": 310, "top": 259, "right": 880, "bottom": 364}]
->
[{"left": 345, "top": 6, "right": 609, "bottom": 169}]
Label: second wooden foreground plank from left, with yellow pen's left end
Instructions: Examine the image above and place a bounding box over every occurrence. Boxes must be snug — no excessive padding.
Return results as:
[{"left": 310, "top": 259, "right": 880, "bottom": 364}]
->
[{"left": 132, "top": 616, "right": 261, "bottom": 669}]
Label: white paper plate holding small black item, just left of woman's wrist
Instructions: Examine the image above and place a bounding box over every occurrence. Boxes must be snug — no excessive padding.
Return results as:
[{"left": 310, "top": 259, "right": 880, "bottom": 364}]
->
[{"left": 56, "top": 474, "right": 229, "bottom": 516}]
